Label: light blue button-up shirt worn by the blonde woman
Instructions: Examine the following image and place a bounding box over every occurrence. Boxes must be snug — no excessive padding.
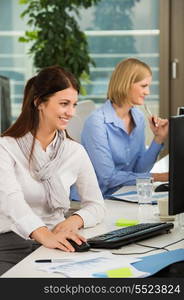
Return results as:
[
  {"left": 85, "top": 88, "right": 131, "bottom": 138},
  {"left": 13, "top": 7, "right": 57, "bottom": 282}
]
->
[{"left": 81, "top": 100, "right": 163, "bottom": 197}]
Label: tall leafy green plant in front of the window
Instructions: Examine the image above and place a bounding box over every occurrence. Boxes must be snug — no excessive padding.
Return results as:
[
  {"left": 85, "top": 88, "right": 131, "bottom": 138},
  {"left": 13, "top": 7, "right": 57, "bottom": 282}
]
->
[{"left": 19, "top": 0, "right": 100, "bottom": 94}]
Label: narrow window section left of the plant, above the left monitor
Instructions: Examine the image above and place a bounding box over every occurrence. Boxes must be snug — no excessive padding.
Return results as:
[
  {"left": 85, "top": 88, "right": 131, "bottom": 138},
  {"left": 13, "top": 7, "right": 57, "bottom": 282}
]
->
[{"left": 0, "top": 0, "right": 32, "bottom": 121}]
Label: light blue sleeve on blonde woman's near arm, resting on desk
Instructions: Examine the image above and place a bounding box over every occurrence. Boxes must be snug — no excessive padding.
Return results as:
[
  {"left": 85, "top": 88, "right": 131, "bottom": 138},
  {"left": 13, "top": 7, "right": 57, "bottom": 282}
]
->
[{"left": 81, "top": 117, "right": 157, "bottom": 194}]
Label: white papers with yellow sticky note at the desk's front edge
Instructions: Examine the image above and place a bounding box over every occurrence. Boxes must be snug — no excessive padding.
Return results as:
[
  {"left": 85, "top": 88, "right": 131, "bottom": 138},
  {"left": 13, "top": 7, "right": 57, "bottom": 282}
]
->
[{"left": 36, "top": 251, "right": 148, "bottom": 278}]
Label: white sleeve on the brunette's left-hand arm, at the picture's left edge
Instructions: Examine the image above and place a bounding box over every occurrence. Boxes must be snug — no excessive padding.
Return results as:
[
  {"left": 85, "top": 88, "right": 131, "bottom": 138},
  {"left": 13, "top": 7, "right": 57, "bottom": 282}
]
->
[{"left": 0, "top": 145, "right": 46, "bottom": 239}]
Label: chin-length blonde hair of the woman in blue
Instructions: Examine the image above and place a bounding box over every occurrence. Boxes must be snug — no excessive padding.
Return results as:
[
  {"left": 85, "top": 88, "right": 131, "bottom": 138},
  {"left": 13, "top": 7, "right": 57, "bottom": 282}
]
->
[{"left": 107, "top": 58, "right": 152, "bottom": 106}]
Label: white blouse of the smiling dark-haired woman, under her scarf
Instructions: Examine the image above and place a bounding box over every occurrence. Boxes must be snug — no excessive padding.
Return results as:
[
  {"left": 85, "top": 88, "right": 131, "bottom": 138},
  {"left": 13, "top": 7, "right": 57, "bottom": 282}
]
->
[{"left": 0, "top": 136, "right": 105, "bottom": 239}]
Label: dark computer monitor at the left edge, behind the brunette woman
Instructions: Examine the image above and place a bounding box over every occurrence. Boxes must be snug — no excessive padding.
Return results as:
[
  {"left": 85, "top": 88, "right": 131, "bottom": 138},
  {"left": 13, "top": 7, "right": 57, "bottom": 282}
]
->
[{"left": 0, "top": 75, "right": 12, "bottom": 133}]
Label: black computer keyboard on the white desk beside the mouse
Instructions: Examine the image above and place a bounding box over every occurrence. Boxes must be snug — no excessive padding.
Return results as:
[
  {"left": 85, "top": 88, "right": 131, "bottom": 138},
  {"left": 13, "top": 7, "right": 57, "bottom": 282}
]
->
[{"left": 87, "top": 222, "right": 174, "bottom": 249}]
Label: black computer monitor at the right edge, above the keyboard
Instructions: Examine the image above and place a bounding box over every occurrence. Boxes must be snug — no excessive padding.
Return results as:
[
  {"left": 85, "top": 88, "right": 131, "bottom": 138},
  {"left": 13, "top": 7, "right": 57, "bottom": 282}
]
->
[{"left": 169, "top": 115, "right": 184, "bottom": 215}]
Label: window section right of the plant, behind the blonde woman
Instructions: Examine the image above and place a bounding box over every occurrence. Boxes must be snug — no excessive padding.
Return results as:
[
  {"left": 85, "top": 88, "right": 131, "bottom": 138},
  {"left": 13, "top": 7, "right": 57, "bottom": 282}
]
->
[{"left": 79, "top": 0, "right": 160, "bottom": 143}]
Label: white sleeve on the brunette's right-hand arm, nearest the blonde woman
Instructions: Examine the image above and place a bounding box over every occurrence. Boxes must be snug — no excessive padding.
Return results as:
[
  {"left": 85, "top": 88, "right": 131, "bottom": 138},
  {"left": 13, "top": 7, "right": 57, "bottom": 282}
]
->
[{"left": 72, "top": 146, "right": 106, "bottom": 228}]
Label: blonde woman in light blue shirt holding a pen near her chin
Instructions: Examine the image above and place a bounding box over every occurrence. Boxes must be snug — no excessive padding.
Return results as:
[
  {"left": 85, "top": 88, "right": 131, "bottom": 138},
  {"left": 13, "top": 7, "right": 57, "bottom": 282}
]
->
[{"left": 81, "top": 58, "right": 168, "bottom": 197}]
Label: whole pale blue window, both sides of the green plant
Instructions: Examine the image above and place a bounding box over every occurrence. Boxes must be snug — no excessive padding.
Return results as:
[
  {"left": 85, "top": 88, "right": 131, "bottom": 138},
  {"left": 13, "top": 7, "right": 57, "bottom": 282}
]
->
[{"left": 0, "top": 0, "right": 159, "bottom": 142}]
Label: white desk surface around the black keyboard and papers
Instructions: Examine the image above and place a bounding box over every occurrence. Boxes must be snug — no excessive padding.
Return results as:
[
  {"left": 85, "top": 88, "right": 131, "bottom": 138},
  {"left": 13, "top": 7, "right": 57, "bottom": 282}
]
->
[{"left": 2, "top": 200, "right": 184, "bottom": 278}]
